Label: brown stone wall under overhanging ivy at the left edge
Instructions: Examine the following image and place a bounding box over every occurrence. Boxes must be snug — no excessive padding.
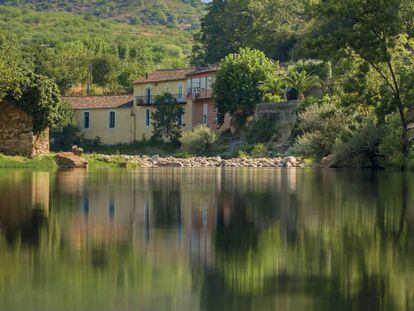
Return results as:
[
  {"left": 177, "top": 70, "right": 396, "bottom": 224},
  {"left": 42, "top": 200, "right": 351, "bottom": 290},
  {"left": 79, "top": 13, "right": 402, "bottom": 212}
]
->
[{"left": 0, "top": 102, "right": 49, "bottom": 156}]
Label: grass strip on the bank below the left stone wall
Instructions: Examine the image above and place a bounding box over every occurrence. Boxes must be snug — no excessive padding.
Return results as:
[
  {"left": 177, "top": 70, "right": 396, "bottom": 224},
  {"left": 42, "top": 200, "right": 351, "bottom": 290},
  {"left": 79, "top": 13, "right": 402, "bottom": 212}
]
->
[{"left": 0, "top": 154, "right": 58, "bottom": 170}]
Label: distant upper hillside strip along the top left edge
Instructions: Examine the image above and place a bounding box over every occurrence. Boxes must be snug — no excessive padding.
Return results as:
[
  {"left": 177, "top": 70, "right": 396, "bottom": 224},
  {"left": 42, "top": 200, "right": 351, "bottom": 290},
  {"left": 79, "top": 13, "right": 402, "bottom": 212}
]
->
[{"left": 0, "top": 0, "right": 203, "bottom": 29}]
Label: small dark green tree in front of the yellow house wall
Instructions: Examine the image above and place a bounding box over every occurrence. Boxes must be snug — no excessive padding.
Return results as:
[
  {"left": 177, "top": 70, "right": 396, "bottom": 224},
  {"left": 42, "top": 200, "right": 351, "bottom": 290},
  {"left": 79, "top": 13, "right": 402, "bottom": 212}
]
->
[{"left": 151, "top": 93, "right": 184, "bottom": 144}]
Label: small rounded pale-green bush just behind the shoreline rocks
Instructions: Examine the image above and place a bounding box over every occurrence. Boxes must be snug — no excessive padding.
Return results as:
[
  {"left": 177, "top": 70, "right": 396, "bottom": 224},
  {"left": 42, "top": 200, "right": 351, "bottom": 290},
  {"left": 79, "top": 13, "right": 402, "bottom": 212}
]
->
[{"left": 181, "top": 125, "right": 217, "bottom": 155}]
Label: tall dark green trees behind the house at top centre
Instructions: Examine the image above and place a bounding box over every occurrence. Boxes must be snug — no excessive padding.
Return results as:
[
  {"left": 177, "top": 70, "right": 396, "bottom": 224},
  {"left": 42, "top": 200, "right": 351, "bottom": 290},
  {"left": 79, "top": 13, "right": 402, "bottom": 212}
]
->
[{"left": 192, "top": 0, "right": 306, "bottom": 65}]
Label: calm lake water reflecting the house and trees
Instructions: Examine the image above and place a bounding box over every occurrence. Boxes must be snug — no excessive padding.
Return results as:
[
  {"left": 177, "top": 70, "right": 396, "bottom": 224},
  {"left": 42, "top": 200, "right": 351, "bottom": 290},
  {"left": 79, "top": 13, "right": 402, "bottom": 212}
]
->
[{"left": 0, "top": 169, "right": 414, "bottom": 311}]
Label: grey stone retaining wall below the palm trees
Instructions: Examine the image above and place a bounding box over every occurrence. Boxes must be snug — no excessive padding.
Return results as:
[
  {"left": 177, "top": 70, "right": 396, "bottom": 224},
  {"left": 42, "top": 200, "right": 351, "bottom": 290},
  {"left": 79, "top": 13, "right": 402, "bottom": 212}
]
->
[{"left": 255, "top": 100, "right": 299, "bottom": 145}]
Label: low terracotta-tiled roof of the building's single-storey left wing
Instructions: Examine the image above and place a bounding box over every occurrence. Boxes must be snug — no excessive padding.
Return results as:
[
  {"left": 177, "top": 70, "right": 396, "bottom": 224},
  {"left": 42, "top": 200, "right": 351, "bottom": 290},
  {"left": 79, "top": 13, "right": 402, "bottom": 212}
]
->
[{"left": 65, "top": 95, "right": 134, "bottom": 109}]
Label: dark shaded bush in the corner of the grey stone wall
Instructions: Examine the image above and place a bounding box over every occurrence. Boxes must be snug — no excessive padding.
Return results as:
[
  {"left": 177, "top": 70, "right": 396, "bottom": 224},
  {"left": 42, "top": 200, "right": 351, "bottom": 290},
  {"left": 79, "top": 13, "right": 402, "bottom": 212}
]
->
[{"left": 243, "top": 118, "right": 279, "bottom": 144}]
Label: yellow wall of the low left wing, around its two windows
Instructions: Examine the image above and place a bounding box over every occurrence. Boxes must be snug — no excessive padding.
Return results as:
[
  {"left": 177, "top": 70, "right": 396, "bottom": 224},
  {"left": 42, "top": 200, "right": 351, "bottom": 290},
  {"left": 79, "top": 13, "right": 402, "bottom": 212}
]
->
[{"left": 74, "top": 108, "right": 134, "bottom": 145}]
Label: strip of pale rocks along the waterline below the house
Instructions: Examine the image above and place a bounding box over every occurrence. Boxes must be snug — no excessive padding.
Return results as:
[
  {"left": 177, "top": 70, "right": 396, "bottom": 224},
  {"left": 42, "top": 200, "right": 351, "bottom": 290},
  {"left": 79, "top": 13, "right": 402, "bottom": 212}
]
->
[{"left": 92, "top": 154, "right": 304, "bottom": 168}]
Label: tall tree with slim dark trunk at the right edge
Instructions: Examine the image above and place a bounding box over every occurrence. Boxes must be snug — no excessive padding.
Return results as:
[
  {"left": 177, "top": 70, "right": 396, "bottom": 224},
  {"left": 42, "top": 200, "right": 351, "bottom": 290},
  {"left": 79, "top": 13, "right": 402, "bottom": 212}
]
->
[{"left": 310, "top": 0, "right": 414, "bottom": 161}]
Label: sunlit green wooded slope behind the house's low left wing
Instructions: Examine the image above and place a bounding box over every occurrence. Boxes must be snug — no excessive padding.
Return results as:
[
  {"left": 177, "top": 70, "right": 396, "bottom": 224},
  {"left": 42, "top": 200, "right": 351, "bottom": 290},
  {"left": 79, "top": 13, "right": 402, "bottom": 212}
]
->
[{"left": 0, "top": 6, "right": 191, "bottom": 94}]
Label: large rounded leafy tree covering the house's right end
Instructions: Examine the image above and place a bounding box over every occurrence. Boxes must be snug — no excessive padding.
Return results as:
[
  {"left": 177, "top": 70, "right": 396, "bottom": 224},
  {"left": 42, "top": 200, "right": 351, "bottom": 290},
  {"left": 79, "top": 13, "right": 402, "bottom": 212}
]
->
[{"left": 214, "top": 48, "right": 277, "bottom": 127}]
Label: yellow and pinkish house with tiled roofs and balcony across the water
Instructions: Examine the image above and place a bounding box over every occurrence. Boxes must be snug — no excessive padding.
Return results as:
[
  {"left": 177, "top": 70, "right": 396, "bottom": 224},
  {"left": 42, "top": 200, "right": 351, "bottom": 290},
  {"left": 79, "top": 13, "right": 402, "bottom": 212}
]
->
[{"left": 66, "top": 66, "right": 230, "bottom": 145}]
